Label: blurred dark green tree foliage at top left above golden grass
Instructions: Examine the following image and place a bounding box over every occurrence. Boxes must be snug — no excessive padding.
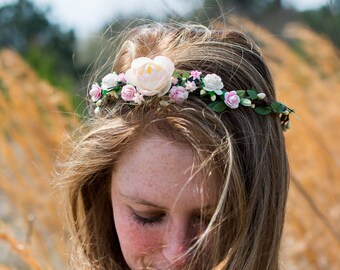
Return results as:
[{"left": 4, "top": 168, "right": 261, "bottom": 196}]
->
[{"left": 0, "top": 0, "right": 76, "bottom": 89}]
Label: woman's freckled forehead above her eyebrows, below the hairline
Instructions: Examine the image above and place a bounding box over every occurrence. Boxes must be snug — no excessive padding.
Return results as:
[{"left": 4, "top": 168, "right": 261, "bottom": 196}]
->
[{"left": 112, "top": 136, "right": 216, "bottom": 207}]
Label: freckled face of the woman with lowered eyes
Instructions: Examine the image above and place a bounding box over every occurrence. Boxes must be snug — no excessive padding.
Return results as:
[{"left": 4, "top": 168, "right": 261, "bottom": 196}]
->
[{"left": 111, "top": 137, "right": 217, "bottom": 270}]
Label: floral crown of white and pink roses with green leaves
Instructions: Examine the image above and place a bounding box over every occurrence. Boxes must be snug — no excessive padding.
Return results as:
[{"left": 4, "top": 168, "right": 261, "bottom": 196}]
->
[{"left": 89, "top": 56, "right": 294, "bottom": 131}]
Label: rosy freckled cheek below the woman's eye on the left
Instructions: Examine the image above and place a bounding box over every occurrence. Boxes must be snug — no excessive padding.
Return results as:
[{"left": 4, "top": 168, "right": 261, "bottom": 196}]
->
[{"left": 114, "top": 205, "right": 162, "bottom": 262}]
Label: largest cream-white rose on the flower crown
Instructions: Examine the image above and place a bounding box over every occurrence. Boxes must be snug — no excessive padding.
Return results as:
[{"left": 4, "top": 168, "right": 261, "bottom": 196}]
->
[{"left": 125, "top": 56, "right": 175, "bottom": 96}]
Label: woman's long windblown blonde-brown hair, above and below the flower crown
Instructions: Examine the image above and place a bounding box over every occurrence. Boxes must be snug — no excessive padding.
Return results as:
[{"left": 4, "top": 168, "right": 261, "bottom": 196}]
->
[{"left": 61, "top": 24, "right": 289, "bottom": 270}]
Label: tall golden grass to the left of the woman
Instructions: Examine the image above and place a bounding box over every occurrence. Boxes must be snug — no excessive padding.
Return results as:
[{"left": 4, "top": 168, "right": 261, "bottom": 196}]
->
[{"left": 0, "top": 50, "right": 77, "bottom": 269}]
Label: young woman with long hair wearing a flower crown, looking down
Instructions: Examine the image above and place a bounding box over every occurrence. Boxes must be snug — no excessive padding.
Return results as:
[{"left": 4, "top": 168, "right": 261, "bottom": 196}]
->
[{"left": 62, "top": 24, "right": 293, "bottom": 270}]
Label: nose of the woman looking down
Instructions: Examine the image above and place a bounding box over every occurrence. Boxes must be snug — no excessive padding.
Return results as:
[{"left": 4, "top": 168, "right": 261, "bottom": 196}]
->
[{"left": 163, "top": 220, "right": 190, "bottom": 269}]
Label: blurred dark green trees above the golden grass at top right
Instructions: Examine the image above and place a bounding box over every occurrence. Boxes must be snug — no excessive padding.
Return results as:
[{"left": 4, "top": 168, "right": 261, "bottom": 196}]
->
[{"left": 198, "top": 0, "right": 340, "bottom": 47}]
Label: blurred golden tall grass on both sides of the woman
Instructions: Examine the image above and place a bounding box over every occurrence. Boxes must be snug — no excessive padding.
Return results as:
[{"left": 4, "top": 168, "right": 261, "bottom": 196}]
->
[{"left": 0, "top": 17, "right": 340, "bottom": 270}]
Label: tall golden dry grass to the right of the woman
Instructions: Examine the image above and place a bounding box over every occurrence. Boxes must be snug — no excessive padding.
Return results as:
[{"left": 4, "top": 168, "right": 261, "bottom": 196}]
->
[{"left": 228, "top": 18, "right": 340, "bottom": 270}]
